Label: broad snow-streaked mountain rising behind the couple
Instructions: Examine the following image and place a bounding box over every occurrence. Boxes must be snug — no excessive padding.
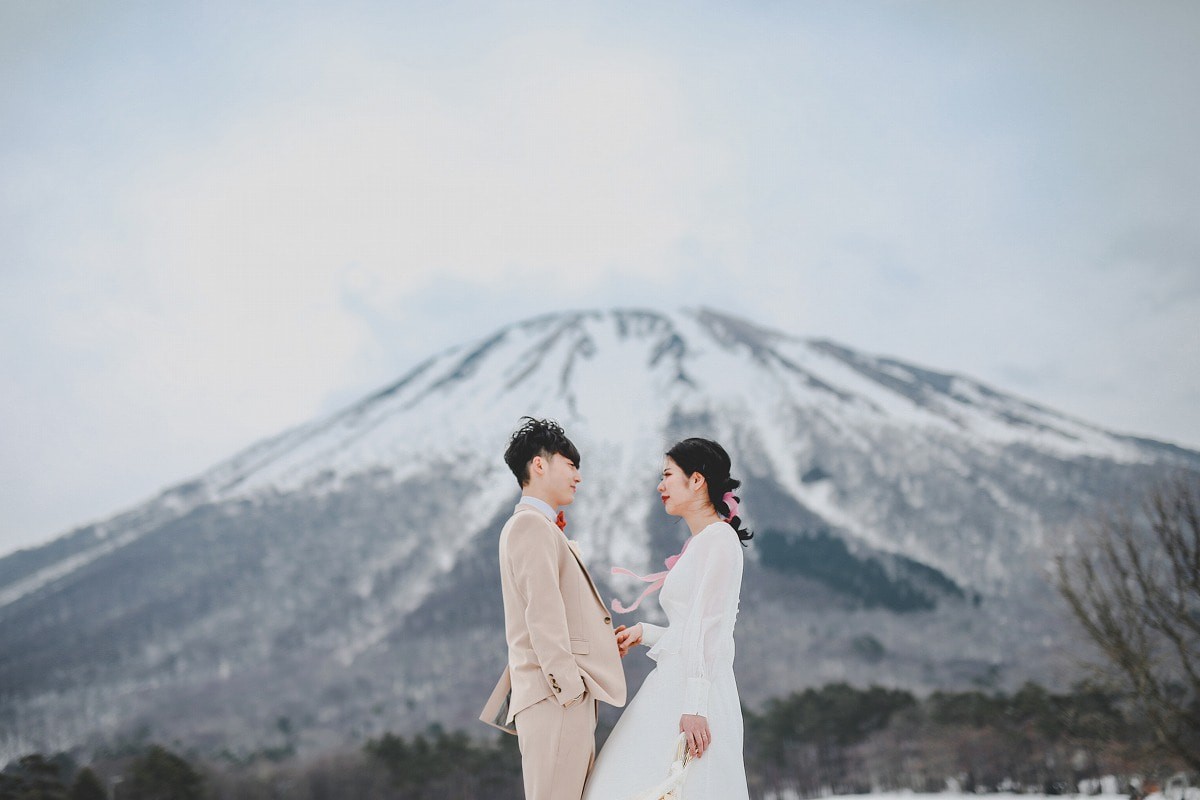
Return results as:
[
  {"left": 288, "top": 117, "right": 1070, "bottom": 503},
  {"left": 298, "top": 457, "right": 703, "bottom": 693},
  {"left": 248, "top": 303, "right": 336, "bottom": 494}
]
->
[{"left": 0, "top": 309, "right": 1200, "bottom": 759}]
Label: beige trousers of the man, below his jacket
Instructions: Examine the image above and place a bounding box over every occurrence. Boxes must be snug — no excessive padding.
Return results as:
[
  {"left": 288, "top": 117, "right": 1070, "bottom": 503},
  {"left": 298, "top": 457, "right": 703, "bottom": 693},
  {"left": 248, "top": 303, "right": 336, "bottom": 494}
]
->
[{"left": 512, "top": 696, "right": 596, "bottom": 800}]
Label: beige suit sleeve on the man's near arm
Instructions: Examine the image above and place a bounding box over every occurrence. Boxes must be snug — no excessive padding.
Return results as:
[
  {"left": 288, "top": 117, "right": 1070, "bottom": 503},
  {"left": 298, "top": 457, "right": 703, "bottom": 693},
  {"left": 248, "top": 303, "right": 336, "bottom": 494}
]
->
[{"left": 509, "top": 522, "right": 586, "bottom": 706}]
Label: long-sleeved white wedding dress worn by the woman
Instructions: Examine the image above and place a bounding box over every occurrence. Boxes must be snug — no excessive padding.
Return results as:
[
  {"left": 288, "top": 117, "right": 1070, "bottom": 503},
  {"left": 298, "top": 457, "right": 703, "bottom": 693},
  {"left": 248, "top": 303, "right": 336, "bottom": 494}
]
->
[{"left": 583, "top": 522, "right": 749, "bottom": 800}]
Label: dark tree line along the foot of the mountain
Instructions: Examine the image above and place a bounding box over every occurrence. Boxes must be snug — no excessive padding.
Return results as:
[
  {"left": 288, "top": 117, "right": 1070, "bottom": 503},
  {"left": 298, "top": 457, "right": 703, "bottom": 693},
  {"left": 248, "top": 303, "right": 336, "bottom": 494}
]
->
[{"left": 0, "top": 684, "right": 1186, "bottom": 800}]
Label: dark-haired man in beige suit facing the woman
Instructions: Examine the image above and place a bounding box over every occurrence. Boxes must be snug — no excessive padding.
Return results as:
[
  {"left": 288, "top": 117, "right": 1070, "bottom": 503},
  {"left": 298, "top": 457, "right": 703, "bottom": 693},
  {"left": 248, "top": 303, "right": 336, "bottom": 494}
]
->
[{"left": 479, "top": 417, "right": 625, "bottom": 800}]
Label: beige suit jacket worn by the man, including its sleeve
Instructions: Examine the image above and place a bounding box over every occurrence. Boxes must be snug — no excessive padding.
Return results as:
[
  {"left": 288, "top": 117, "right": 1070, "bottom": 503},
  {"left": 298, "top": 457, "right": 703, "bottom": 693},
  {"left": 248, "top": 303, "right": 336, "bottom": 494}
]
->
[{"left": 479, "top": 505, "right": 625, "bottom": 733}]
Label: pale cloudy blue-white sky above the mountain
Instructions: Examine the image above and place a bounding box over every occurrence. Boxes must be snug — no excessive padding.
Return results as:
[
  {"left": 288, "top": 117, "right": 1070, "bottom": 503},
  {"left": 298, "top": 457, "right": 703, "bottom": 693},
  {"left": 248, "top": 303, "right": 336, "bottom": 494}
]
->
[{"left": 0, "top": 0, "right": 1200, "bottom": 554}]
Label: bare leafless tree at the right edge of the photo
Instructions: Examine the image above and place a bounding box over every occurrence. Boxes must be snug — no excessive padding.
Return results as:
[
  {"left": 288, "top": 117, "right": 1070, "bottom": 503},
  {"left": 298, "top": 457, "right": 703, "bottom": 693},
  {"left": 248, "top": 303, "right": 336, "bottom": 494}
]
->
[{"left": 1056, "top": 474, "right": 1200, "bottom": 770}]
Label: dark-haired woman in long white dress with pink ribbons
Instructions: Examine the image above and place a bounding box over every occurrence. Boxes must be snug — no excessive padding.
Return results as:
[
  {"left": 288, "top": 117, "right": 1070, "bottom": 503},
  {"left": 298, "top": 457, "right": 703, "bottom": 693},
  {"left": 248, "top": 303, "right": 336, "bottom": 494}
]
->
[{"left": 583, "top": 439, "right": 754, "bottom": 800}]
